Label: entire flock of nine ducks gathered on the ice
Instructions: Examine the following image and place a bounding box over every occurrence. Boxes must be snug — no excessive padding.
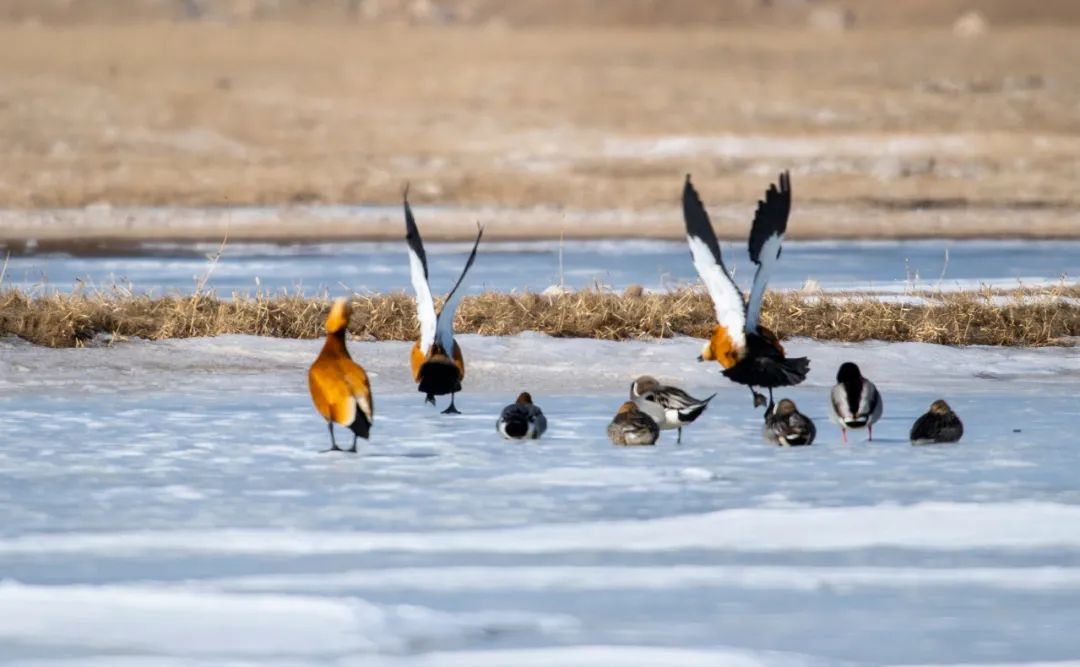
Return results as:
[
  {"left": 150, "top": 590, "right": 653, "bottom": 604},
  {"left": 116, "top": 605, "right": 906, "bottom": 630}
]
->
[{"left": 308, "top": 172, "right": 963, "bottom": 452}]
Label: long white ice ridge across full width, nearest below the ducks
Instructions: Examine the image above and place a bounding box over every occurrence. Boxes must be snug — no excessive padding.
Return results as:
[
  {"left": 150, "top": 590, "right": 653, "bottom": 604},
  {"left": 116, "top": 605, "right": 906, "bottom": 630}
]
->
[{"left": 0, "top": 501, "right": 1080, "bottom": 556}]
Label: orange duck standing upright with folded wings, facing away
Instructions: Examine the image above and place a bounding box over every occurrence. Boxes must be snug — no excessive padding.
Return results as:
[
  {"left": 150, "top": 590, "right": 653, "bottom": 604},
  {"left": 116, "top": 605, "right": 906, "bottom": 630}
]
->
[{"left": 308, "top": 299, "right": 375, "bottom": 453}]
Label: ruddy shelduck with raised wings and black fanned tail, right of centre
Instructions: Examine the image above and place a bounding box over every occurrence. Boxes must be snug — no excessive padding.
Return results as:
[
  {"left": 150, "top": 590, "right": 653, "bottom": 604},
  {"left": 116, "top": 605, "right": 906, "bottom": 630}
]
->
[{"left": 683, "top": 172, "right": 810, "bottom": 407}]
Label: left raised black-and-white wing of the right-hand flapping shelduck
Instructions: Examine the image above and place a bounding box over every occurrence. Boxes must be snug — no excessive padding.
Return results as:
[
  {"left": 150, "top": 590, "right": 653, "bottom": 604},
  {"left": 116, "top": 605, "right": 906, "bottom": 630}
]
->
[{"left": 683, "top": 175, "right": 746, "bottom": 348}]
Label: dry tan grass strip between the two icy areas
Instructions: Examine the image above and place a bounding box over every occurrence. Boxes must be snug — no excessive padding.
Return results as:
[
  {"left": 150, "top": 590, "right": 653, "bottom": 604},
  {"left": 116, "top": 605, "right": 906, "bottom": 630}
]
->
[{"left": 0, "top": 286, "right": 1080, "bottom": 348}]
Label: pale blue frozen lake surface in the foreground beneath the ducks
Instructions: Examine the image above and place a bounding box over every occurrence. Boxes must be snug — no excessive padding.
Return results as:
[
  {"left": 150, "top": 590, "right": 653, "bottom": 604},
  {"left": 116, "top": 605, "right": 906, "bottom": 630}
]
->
[{"left": 0, "top": 334, "right": 1080, "bottom": 667}]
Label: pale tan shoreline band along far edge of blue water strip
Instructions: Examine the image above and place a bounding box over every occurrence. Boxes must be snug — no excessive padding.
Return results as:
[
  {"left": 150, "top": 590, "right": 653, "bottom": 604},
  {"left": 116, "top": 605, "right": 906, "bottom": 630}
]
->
[{"left": 0, "top": 202, "right": 1080, "bottom": 250}]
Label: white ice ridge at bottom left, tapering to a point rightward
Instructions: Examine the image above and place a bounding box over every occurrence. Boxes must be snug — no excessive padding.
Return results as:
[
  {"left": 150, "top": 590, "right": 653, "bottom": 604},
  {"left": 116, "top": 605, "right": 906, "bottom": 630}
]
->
[{"left": 0, "top": 582, "right": 576, "bottom": 664}]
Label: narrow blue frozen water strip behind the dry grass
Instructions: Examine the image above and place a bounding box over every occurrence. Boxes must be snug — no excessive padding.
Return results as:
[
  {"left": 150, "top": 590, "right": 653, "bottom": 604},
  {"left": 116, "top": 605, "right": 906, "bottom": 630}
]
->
[{"left": 4, "top": 240, "right": 1080, "bottom": 296}]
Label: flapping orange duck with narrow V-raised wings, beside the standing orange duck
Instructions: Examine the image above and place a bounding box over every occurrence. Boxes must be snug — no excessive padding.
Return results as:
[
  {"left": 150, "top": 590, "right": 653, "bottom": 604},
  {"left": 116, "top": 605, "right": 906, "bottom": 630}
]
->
[{"left": 405, "top": 188, "right": 484, "bottom": 414}]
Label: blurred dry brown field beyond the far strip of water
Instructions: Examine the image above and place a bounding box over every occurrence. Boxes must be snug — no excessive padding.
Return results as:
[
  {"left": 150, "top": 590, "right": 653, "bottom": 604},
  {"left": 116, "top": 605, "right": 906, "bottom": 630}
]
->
[{"left": 0, "top": 17, "right": 1080, "bottom": 244}]
